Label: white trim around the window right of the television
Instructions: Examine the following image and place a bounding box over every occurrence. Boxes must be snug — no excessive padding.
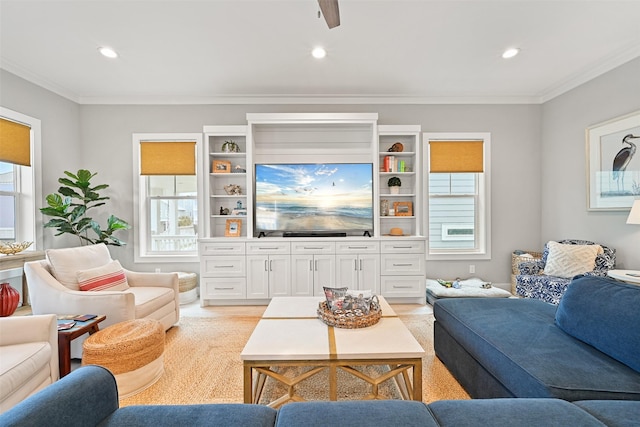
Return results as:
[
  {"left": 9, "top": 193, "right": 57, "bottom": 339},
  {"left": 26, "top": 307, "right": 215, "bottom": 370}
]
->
[{"left": 422, "top": 132, "right": 491, "bottom": 261}]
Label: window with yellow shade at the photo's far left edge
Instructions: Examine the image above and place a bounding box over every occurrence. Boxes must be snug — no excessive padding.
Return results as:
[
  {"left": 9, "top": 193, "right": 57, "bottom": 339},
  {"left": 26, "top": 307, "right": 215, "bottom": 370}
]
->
[{"left": 0, "top": 107, "right": 43, "bottom": 250}]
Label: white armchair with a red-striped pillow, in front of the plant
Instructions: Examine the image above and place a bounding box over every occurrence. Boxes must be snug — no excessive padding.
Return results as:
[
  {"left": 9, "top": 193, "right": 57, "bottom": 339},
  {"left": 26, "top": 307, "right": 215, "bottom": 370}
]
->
[{"left": 24, "top": 244, "right": 180, "bottom": 358}]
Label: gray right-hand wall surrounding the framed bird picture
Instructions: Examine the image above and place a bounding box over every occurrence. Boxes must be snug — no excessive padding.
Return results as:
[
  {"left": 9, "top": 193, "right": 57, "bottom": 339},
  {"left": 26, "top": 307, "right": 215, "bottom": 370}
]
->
[{"left": 540, "top": 58, "right": 640, "bottom": 270}]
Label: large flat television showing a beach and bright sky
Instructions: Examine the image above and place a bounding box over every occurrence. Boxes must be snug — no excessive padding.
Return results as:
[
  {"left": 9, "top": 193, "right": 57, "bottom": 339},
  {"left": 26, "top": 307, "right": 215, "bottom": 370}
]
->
[{"left": 253, "top": 163, "right": 373, "bottom": 237}]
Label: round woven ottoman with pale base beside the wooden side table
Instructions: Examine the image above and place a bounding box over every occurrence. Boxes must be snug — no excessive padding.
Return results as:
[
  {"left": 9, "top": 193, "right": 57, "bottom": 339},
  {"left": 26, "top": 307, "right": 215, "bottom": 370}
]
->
[{"left": 82, "top": 319, "right": 165, "bottom": 399}]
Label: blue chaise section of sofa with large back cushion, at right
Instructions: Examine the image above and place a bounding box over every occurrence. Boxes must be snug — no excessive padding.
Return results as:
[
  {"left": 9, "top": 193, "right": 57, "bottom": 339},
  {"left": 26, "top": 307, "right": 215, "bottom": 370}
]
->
[{"left": 434, "top": 275, "right": 640, "bottom": 402}]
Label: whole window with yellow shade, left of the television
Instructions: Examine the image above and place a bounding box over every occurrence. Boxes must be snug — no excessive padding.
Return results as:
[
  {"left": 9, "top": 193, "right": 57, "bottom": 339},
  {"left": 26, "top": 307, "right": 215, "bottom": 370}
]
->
[{"left": 133, "top": 134, "right": 202, "bottom": 262}]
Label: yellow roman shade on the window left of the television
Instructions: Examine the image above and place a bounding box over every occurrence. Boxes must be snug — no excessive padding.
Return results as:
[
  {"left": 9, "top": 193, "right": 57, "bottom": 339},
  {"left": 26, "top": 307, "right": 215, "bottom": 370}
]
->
[{"left": 140, "top": 141, "right": 196, "bottom": 175}]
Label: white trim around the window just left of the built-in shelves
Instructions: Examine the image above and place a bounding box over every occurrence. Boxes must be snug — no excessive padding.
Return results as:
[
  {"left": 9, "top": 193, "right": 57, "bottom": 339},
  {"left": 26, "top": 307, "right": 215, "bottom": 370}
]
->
[{"left": 132, "top": 133, "right": 203, "bottom": 263}]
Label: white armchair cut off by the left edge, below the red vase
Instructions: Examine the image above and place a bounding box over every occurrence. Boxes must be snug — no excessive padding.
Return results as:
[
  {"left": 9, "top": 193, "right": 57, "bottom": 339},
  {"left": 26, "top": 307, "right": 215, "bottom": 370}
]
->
[{"left": 0, "top": 314, "right": 59, "bottom": 413}]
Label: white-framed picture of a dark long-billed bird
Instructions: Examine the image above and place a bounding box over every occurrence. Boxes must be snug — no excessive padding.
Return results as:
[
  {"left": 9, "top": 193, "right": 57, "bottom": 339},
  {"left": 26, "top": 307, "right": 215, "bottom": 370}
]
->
[{"left": 586, "top": 111, "right": 640, "bottom": 211}]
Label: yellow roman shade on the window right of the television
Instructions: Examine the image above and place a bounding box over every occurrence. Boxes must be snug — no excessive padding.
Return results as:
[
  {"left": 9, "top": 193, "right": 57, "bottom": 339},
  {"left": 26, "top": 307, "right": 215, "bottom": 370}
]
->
[{"left": 429, "top": 140, "right": 484, "bottom": 173}]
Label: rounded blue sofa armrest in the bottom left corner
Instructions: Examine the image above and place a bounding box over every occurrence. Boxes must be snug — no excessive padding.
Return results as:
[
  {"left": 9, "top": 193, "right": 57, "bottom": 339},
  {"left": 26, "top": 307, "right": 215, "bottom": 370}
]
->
[{"left": 0, "top": 366, "right": 118, "bottom": 427}]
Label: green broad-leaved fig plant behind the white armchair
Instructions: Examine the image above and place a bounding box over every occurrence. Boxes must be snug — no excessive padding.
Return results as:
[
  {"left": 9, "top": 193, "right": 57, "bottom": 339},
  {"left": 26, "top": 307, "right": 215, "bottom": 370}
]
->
[{"left": 40, "top": 169, "right": 130, "bottom": 246}]
